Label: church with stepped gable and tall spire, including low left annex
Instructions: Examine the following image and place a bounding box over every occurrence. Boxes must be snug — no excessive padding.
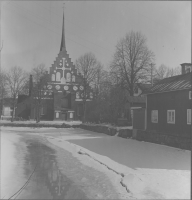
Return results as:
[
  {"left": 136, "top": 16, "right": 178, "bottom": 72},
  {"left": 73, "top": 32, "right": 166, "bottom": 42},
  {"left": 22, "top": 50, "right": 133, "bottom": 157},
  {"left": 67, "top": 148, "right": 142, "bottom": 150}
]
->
[{"left": 16, "top": 13, "right": 93, "bottom": 121}]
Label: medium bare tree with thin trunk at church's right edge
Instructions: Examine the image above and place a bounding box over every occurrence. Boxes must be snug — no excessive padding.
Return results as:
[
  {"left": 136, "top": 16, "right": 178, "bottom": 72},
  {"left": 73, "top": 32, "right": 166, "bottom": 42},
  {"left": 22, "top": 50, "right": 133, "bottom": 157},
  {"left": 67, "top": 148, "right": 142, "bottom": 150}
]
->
[{"left": 76, "top": 53, "right": 101, "bottom": 122}]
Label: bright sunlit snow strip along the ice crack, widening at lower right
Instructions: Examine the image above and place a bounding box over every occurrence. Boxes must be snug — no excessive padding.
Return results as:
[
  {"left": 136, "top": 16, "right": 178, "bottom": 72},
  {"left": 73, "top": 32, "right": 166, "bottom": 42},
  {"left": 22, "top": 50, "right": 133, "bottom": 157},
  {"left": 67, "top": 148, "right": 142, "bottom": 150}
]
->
[{"left": 47, "top": 136, "right": 190, "bottom": 199}]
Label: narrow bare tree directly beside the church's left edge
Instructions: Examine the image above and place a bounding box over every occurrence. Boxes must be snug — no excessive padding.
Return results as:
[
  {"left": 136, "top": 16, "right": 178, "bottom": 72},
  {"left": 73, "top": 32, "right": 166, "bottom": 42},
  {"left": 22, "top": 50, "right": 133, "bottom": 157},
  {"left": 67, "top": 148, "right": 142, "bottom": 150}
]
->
[{"left": 31, "top": 63, "right": 48, "bottom": 123}]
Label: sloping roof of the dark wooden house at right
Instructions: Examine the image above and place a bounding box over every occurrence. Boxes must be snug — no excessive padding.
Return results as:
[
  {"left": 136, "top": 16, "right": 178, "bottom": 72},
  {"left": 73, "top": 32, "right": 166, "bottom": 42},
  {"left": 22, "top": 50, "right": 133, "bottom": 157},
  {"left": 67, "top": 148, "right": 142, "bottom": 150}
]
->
[{"left": 146, "top": 73, "right": 192, "bottom": 94}]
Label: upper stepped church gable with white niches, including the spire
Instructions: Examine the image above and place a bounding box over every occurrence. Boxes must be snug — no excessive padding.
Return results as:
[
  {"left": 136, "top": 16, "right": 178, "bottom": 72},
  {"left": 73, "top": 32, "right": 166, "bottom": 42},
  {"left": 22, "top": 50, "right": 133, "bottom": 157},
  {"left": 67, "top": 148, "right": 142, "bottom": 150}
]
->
[{"left": 46, "top": 9, "right": 93, "bottom": 99}]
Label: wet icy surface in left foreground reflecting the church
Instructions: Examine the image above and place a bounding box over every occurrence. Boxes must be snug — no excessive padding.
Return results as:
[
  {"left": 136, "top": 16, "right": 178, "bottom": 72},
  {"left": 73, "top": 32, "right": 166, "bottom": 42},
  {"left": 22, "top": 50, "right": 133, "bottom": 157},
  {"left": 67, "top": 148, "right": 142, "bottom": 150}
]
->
[{"left": 1, "top": 128, "right": 128, "bottom": 199}]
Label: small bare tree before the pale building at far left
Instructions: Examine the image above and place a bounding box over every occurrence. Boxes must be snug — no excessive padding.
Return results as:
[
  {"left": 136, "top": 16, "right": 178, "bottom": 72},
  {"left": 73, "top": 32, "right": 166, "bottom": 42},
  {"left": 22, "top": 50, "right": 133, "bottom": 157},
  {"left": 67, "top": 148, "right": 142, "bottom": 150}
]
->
[{"left": 6, "top": 66, "right": 27, "bottom": 121}]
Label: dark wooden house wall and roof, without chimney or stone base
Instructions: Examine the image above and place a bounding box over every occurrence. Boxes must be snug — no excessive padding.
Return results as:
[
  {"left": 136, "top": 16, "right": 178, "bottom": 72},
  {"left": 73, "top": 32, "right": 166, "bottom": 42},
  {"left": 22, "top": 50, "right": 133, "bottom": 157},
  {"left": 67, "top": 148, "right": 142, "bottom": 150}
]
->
[{"left": 146, "top": 65, "right": 192, "bottom": 134}]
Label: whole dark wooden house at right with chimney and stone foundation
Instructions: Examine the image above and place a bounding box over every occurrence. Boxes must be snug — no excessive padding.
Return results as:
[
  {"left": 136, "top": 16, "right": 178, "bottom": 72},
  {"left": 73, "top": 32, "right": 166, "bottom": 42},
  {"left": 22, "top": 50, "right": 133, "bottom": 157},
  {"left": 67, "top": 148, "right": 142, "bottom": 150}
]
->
[{"left": 134, "top": 63, "right": 192, "bottom": 149}]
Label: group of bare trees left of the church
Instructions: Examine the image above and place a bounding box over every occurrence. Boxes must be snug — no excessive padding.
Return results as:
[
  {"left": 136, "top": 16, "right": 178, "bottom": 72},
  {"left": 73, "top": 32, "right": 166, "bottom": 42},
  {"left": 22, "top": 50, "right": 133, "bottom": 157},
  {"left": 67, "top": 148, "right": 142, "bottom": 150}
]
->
[{"left": 0, "top": 64, "right": 46, "bottom": 121}]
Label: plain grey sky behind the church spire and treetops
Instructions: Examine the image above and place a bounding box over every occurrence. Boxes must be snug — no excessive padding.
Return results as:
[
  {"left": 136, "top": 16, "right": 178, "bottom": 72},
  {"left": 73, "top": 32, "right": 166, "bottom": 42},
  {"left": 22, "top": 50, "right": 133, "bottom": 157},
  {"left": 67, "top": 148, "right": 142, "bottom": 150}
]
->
[{"left": 1, "top": 1, "right": 191, "bottom": 71}]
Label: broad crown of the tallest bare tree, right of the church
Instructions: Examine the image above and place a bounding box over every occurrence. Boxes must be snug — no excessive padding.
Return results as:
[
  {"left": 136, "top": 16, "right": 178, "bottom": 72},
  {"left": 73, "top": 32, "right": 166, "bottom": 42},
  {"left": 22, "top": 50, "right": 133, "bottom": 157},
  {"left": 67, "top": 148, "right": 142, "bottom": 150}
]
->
[{"left": 111, "top": 31, "right": 154, "bottom": 96}]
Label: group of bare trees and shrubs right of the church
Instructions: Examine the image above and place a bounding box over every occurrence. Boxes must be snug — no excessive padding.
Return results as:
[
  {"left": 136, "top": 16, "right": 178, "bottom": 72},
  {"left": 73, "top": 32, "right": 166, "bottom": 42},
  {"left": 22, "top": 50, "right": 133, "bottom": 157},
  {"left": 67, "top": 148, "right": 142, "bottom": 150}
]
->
[{"left": 76, "top": 31, "right": 181, "bottom": 122}]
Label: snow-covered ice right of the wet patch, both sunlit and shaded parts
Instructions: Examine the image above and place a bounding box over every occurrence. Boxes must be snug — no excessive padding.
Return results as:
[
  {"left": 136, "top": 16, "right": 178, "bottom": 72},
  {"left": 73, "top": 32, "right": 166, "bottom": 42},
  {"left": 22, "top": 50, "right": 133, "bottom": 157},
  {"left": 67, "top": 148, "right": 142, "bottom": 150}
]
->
[{"left": 3, "top": 127, "right": 191, "bottom": 199}]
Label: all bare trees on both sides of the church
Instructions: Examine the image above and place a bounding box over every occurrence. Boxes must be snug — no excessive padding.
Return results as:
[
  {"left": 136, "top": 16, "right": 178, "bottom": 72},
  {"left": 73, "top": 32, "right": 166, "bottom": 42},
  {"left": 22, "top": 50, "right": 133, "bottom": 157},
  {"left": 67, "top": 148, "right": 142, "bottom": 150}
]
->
[{"left": 0, "top": 31, "right": 180, "bottom": 122}]
